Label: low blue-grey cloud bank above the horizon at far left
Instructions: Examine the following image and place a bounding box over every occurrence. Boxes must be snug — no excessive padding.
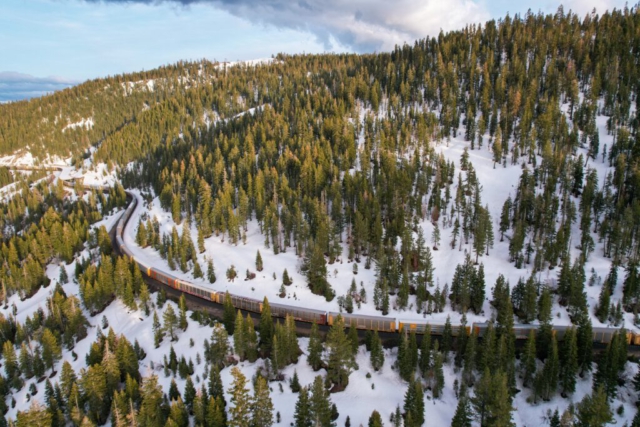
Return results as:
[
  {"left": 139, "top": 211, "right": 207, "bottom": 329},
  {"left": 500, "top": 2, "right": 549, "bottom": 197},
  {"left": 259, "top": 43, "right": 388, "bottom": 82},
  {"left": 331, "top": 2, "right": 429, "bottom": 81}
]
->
[{"left": 0, "top": 71, "right": 78, "bottom": 102}]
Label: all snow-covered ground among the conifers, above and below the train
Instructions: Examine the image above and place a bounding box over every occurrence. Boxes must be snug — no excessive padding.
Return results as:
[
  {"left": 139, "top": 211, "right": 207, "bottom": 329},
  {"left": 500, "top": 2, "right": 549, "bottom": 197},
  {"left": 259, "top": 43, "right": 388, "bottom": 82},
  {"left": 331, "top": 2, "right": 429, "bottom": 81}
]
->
[{"left": 0, "top": 92, "right": 638, "bottom": 427}]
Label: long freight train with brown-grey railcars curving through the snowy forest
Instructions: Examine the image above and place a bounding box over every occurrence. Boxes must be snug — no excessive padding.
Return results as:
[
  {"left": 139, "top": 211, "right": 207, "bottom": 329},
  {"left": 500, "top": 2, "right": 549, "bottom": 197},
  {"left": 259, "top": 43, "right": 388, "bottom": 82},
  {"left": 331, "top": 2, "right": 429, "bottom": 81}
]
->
[{"left": 110, "top": 192, "right": 640, "bottom": 346}]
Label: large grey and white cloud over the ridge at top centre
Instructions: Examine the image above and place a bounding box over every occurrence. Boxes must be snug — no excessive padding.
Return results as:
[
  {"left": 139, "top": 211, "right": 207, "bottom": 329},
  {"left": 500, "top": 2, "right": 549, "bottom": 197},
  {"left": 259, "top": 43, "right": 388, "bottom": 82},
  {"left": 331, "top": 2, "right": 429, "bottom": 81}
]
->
[{"left": 80, "top": 0, "right": 490, "bottom": 52}]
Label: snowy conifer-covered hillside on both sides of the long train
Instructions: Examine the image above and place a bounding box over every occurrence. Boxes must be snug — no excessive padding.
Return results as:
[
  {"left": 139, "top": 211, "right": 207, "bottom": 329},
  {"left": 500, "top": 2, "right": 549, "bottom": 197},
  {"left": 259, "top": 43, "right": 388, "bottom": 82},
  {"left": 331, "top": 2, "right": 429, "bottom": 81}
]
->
[{"left": 0, "top": 7, "right": 640, "bottom": 427}]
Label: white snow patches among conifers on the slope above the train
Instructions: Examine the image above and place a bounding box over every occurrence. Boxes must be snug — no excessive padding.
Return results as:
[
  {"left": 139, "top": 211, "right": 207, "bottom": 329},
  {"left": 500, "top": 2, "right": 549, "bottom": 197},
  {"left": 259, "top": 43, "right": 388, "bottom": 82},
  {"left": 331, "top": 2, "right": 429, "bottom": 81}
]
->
[{"left": 117, "top": 98, "right": 640, "bottom": 331}]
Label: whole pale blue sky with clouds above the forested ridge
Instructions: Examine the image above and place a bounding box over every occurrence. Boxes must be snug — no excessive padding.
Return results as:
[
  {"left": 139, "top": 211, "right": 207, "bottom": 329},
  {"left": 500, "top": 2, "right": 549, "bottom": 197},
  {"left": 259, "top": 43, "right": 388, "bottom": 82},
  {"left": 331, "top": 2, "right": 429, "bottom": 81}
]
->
[{"left": 0, "top": 0, "right": 625, "bottom": 102}]
